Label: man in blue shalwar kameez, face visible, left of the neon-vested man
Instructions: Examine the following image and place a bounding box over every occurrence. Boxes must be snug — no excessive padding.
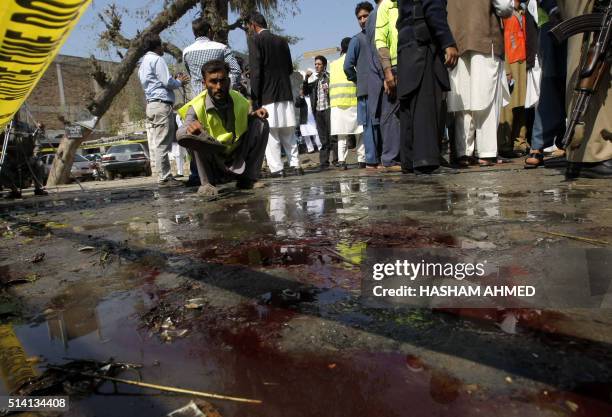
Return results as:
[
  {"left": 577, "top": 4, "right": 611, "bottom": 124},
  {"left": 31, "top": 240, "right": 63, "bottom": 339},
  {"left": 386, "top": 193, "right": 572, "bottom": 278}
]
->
[{"left": 344, "top": 1, "right": 379, "bottom": 169}]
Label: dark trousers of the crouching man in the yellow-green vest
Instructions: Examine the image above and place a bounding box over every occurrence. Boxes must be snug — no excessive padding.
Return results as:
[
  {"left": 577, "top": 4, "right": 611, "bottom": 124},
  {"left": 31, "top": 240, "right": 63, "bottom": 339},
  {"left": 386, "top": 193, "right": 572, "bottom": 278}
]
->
[{"left": 194, "top": 118, "right": 270, "bottom": 185}]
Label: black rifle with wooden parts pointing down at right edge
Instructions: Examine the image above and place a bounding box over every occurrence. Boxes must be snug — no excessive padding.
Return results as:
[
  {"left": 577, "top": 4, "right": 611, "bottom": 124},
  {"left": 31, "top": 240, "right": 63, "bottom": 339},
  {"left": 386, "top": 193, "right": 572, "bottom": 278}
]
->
[{"left": 550, "top": 2, "right": 612, "bottom": 149}]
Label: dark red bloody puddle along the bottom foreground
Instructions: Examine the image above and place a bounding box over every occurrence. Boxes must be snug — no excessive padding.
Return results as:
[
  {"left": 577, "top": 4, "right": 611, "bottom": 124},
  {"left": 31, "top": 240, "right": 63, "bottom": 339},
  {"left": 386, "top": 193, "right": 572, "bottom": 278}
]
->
[{"left": 0, "top": 282, "right": 612, "bottom": 417}]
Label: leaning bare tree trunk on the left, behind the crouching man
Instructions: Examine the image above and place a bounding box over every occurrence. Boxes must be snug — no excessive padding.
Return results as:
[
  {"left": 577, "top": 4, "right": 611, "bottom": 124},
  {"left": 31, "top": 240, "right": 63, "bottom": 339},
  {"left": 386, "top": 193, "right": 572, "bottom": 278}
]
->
[{"left": 47, "top": 0, "right": 198, "bottom": 186}]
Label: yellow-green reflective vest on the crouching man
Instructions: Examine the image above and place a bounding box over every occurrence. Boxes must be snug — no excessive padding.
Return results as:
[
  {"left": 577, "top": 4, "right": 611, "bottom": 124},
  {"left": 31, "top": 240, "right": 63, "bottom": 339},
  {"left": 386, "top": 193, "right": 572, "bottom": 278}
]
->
[{"left": 178, "top": 90, "right": 250, "bottom": 155}]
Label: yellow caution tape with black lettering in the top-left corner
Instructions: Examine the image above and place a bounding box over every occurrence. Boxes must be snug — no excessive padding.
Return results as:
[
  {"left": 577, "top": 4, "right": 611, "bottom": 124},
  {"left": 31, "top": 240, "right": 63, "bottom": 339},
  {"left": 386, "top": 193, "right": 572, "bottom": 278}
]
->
[{"left": 0, "top": 0, "right": 91, "bottom": 130}]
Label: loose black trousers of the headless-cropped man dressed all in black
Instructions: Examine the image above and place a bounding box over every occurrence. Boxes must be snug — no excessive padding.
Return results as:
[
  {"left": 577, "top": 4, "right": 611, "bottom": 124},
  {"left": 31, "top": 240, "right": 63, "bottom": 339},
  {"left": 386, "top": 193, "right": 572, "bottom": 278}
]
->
[{"left": 399, "top": 48, "right": 445, "bottom": 170}]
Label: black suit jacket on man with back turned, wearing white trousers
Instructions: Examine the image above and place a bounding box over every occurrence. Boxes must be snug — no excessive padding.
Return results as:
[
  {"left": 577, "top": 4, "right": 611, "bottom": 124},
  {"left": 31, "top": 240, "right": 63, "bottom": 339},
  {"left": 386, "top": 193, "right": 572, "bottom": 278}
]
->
[{"left": 249, "top": 30, "right": 293, "bottom": 108}]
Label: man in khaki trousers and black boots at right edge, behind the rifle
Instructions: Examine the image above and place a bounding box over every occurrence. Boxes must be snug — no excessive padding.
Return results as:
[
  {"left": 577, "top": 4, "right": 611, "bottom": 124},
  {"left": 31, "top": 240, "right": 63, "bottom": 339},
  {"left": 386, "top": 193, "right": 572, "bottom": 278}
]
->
[{"left": 558, "top": 0, "right": 612, "bottom": 179}]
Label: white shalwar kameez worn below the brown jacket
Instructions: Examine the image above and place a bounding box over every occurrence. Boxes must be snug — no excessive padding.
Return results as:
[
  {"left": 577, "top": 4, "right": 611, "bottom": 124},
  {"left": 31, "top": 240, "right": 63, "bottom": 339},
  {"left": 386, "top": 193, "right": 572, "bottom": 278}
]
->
[{"left": 448, "top": 48, "right": 510, "bottom": 158}]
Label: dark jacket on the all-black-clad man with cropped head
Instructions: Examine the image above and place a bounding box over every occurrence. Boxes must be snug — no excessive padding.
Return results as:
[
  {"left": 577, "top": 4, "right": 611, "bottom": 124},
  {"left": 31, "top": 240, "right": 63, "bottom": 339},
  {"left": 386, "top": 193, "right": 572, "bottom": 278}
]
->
[{"left": 397, "top": 0, "right": 455, "bottom": 98}]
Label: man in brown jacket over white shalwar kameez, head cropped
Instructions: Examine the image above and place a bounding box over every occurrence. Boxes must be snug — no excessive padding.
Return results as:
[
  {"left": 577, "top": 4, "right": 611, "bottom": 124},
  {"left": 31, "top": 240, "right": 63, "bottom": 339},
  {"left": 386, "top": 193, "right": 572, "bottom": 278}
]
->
[{"left": 448, "top": 0, "right": 514, "bottom": 167}]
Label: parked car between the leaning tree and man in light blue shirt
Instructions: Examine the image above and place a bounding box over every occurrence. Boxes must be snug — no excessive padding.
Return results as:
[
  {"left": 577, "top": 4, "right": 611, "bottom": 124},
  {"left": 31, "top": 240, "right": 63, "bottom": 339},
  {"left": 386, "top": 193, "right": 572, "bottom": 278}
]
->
[{"left": 102, "top": 143, "right": 151, "bottom": 180}]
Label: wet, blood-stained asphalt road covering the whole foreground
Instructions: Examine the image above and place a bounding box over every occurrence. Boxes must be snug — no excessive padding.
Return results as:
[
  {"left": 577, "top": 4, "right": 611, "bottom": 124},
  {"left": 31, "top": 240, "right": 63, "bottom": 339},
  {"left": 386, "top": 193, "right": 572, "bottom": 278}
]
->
[{"left": 0, "top": 161, "right": 612, "bottom": 417}]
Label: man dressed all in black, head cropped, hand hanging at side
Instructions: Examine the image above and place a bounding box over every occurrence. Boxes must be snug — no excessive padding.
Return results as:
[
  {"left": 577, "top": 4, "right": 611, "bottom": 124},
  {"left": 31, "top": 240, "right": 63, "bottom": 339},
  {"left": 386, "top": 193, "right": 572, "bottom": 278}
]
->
[{"left": 397, "top": 0, "right": 459, "bottom": 174}]
